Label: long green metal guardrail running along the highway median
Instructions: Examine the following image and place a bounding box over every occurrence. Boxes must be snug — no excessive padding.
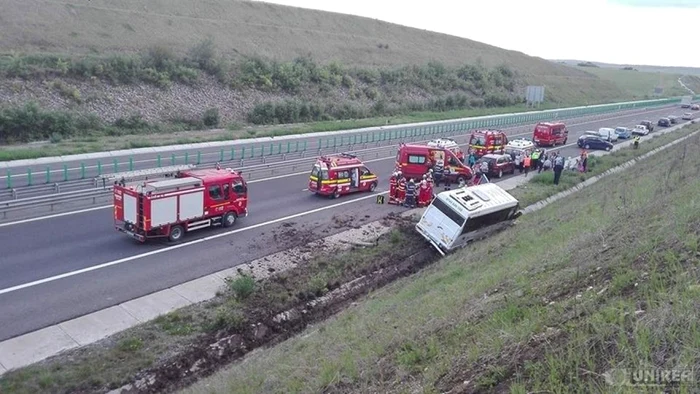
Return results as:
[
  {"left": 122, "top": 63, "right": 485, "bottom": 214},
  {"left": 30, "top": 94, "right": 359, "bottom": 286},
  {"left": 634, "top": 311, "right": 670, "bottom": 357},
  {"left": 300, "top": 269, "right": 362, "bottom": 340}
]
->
[{"left": 0, "top": 96, "right": 700, "bottom": 189}]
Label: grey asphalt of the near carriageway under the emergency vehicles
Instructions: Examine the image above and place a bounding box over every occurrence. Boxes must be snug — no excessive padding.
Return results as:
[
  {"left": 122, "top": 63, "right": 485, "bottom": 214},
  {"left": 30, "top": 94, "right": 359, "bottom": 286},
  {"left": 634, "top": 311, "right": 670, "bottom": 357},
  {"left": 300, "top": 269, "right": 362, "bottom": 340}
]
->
[{"left": 0, "top": 108, "right": 683, "bottom": 340}]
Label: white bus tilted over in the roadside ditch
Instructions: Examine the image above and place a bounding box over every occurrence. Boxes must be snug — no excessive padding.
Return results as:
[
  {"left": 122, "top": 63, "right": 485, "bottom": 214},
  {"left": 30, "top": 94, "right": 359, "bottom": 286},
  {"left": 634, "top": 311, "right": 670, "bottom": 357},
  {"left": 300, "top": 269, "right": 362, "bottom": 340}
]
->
[{"left": 416, "top": 183, "right": 521, "bottom": 255}]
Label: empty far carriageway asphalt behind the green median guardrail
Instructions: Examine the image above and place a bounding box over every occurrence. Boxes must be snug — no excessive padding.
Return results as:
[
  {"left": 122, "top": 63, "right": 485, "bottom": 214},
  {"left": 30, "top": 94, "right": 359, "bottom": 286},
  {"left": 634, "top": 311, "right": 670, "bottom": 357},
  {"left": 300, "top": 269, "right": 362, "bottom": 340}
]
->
[{"left": 0, "top": 106, "right": 674, "bottom": 188}]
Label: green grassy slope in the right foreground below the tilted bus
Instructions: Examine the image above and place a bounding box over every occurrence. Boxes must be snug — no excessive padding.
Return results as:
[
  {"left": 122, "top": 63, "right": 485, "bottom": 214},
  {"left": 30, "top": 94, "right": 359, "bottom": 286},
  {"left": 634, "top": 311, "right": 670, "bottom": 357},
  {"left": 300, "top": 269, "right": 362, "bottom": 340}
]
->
[{"left": 184, "top": 126, "right": 700, "bottom": 394}]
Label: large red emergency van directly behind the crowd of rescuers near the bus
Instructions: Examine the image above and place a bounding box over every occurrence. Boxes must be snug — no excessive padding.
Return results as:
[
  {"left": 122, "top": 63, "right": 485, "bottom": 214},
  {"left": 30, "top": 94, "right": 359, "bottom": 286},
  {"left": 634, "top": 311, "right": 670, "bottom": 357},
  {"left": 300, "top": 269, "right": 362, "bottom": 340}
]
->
[{"left": 396, "top": 144, "right": 472, "bottom": 183}]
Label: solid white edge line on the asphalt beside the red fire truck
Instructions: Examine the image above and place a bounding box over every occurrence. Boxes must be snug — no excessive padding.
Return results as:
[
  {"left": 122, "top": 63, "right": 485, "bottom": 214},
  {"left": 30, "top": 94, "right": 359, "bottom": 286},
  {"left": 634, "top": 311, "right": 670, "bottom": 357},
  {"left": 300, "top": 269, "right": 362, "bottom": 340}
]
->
[{"left": 0, "top": 191, "right": 389, "bottom": 295}]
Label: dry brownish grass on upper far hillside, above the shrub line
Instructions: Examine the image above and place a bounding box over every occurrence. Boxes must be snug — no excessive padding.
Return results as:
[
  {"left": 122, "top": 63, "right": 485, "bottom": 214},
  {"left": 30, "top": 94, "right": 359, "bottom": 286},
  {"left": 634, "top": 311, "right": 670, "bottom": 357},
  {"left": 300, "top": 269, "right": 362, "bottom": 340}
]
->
[{"left": 0, "top": 0, "right": 625, "bottom": 102}]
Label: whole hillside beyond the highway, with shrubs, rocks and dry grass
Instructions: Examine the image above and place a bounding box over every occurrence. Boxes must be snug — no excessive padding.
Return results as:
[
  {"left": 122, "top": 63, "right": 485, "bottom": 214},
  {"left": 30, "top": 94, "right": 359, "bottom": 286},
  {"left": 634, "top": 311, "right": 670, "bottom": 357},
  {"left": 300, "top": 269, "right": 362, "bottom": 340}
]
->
[{"left": 0, "top": 0, "right": 680, "bottom": 151}]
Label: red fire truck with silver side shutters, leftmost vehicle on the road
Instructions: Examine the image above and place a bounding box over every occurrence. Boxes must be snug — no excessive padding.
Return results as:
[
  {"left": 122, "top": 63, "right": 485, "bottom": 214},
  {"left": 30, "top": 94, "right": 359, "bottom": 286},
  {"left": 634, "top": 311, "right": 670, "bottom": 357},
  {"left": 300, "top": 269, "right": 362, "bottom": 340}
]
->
[{"left": 111, "top": 166, "right": 248, "bottom": 242}]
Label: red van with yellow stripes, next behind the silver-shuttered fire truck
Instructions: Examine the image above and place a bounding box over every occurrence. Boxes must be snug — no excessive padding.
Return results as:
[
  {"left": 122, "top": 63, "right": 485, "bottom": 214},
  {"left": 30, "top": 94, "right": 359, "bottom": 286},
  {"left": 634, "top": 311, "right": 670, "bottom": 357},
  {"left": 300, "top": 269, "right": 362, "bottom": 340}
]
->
[{"left": 309, "top": 153, "right": 379, "bottom": 198}]
